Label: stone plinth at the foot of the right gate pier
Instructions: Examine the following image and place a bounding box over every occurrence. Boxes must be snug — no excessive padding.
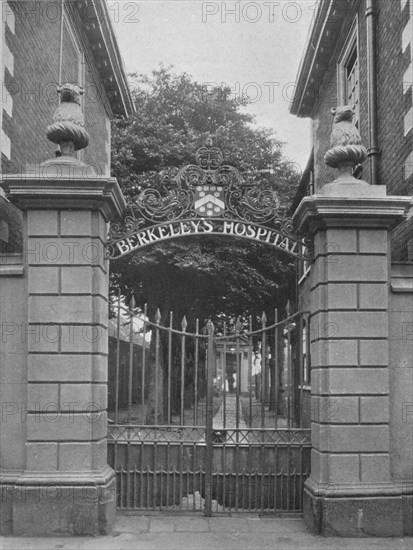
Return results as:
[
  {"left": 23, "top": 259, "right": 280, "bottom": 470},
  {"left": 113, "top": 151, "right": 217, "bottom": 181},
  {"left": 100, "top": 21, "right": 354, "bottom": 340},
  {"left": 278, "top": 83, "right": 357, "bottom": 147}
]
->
[{"left": 303, "top": 485, "right": 413, "bottom": 537}]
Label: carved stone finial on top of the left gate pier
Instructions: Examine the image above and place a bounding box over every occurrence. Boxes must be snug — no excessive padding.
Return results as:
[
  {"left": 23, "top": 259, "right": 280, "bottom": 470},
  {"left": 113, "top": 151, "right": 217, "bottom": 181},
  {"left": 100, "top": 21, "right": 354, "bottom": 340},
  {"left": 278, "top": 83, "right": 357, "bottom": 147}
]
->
[{"left": 46, "top": 84, "right": 89, "bottom": 157}]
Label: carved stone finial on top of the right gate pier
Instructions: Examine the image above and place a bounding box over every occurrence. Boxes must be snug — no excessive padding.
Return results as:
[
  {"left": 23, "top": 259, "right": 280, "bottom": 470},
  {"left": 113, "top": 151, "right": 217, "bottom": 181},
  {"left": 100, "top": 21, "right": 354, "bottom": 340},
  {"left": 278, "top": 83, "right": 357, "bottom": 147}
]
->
[{"left": 324, "top": 105, "right": 367, "bottom": 179}]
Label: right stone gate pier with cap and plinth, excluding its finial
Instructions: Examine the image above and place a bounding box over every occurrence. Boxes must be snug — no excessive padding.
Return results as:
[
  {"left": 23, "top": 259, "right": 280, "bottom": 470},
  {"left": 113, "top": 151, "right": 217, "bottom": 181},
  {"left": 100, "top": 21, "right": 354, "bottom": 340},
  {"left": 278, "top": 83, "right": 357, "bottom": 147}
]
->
[{"left": 294, "top": 181, "right": 413, "bottom": 536}]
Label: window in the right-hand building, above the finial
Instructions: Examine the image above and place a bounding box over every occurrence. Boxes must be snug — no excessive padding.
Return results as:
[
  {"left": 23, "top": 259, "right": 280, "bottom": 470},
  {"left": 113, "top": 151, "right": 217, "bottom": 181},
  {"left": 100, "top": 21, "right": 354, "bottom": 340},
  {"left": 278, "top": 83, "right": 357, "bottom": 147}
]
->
[{"left": 338, "top": 19, "right": 360, "bottom": 127}]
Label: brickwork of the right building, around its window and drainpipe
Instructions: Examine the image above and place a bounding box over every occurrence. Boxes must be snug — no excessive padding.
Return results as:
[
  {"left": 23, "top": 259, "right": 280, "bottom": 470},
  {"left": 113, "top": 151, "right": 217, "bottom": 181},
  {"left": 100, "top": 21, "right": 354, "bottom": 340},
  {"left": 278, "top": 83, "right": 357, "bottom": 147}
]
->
[{"left": 314, "top": 0, "right": 413, "bottom": 260}]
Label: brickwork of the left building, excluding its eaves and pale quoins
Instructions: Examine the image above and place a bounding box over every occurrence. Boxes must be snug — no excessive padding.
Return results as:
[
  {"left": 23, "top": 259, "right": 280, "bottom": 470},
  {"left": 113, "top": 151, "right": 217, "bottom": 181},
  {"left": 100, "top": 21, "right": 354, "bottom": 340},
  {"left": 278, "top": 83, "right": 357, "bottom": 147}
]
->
[{"left": 2, "top": 1, "right": 109, "bottom": 173}]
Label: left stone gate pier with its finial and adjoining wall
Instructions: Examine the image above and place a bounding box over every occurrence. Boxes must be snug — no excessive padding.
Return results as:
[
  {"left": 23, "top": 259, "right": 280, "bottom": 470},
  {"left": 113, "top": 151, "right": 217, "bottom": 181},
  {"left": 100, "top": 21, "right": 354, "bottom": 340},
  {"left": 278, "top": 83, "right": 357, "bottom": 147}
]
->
[{"left": 0, "top": 85, "right": 125, "bottom": 536}]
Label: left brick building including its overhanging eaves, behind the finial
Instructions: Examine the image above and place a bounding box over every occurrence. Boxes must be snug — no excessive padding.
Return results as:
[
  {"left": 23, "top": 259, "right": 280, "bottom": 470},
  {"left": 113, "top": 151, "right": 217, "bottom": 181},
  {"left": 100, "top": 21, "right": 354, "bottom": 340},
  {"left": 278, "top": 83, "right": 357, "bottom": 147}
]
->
[{"left": 0, "top": 0, "right": 133, "bottom": 175}]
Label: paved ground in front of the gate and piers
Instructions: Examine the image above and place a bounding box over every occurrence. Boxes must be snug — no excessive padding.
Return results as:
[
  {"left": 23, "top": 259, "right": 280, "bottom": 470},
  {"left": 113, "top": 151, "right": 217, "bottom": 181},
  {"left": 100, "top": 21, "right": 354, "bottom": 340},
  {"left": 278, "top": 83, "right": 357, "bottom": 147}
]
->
[{"left": 0, "top": 514, "right": 413, "bottom": 550}]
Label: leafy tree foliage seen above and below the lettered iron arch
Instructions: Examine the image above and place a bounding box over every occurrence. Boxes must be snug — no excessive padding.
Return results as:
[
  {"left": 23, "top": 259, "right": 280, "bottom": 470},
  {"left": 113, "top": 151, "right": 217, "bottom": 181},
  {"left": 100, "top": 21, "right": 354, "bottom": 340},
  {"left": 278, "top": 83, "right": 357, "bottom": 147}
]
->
[{"left": 111, "top": 66, "right": 299, "bottom": 329}]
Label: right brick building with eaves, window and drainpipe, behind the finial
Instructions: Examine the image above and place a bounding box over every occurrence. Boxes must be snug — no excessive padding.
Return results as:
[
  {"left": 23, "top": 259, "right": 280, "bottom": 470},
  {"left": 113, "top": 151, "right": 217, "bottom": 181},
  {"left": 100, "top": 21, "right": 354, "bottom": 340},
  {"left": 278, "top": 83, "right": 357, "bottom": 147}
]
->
[{"left": 291, "top": 0, "right": 413, "bottom": 261}]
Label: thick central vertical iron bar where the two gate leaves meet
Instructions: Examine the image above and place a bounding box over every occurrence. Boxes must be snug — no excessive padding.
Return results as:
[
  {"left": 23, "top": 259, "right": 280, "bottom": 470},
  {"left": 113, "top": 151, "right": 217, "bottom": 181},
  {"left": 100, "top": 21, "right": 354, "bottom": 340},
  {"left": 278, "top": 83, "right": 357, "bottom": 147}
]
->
[{"left": 205, "top": 321, "right": 214, "bottom": 517}]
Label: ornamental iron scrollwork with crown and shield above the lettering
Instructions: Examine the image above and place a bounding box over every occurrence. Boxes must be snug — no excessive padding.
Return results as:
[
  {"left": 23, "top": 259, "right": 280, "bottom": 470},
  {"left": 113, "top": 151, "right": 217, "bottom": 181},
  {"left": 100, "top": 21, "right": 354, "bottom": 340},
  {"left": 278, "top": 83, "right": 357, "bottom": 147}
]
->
[{"left": 107, "top": 139, "right": 297, "bottom": 257}]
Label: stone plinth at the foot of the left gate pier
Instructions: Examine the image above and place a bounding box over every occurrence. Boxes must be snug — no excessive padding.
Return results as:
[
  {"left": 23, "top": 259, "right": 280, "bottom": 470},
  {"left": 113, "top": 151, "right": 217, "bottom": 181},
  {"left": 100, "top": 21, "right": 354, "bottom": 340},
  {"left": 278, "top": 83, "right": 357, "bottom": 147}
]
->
[{"left": 0, "top": 467, "right": 116, "bottom": 537}]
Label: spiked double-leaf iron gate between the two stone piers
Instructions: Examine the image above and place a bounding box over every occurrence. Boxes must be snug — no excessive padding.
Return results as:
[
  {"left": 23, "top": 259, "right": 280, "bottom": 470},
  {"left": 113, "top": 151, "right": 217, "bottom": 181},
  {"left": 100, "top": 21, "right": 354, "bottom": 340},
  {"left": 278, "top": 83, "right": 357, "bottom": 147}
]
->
[{"left": 108, "top": 298, "right": 311, "bottom": 515}]
